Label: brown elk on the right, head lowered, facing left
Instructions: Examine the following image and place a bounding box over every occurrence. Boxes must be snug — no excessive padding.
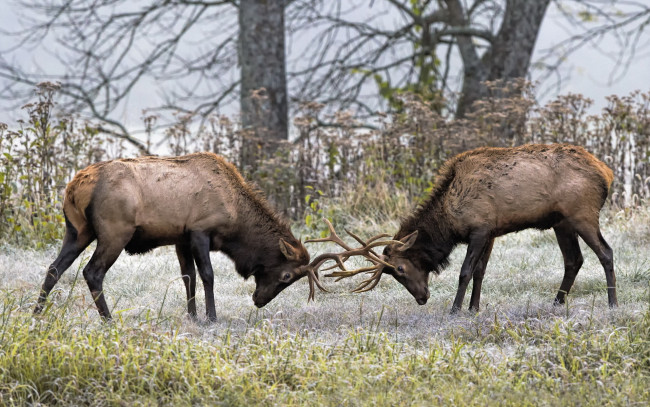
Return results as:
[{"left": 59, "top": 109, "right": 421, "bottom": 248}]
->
[{"left": 329, "top": 144, "right": 617, "bottom": 312}]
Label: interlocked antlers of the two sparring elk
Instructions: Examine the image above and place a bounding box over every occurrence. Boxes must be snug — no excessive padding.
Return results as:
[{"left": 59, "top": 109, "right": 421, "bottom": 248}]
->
[{"left": 305, "top": 219, "right": 403, "bottom": 299}]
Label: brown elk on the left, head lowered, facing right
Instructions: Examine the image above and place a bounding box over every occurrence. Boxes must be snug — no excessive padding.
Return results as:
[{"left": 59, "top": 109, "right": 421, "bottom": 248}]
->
[{"left": 34, "top": 153, "right": 324, "bottom": 320}]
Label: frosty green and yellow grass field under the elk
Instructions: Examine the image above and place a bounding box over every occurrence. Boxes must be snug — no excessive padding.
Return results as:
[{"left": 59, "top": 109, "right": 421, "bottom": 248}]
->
[{"left": 0, "top": 210, "right": 650, "bottom": 406}]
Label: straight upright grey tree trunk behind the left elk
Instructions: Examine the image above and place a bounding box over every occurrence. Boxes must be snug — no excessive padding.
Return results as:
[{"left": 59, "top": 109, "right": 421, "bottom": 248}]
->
[{"left": 239, "top": 0, "right": 288, "bottom": 166}]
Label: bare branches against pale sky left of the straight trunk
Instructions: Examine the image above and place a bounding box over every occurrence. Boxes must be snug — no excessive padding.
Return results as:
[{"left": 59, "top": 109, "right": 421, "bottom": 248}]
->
[{"left": 0, "top": 0, "right": 239, "bottom": 151}]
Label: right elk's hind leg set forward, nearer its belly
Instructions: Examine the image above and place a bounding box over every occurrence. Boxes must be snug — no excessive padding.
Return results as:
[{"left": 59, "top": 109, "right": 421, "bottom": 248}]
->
[{"left": 553, "top": 222, "right": 584, "bottom": 305}]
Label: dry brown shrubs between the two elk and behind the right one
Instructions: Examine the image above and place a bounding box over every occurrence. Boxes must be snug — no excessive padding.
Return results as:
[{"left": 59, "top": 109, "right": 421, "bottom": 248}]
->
[{"left": 157, "top": 80, "right": 650, "bottom": 233}]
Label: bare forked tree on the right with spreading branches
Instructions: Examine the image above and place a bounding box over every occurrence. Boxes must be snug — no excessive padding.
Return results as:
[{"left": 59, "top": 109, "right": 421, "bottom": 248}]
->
[{"left": 287, "top": 0, "right": 650, "bottom": 117}]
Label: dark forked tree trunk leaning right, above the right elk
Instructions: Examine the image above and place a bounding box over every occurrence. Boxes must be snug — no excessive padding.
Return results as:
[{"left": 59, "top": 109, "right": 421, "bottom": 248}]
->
[{"left": 448, "top": 0, "right": 550, "bottom": 118}]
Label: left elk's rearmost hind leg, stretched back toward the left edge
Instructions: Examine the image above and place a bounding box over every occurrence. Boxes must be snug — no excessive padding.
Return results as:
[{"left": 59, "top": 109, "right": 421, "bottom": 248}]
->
[{"left": 34, "top": 222, "right": 95, "bottom": 314}]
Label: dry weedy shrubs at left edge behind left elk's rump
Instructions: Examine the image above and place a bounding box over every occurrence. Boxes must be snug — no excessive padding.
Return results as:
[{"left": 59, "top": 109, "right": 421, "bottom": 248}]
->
[{"left": 0, "top": 82, "right": 114, "bottom": 246}]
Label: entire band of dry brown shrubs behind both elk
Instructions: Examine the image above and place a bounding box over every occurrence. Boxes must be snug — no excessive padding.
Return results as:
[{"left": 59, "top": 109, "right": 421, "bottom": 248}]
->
[{"left": 0, "top": 81, "right": 650, "bottom": 242}]
